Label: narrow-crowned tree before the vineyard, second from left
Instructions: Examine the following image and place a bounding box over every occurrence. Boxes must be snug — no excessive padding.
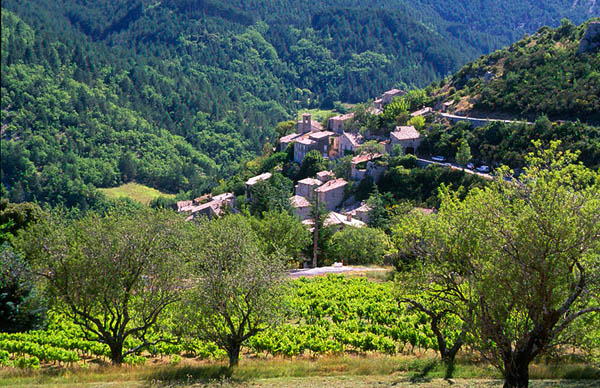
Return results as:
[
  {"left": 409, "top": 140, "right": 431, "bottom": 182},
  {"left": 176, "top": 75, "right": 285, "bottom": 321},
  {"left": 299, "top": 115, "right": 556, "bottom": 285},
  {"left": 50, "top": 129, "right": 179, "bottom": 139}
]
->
[{"left": 179, "top": 215, "right": 285, "bottom": 367}]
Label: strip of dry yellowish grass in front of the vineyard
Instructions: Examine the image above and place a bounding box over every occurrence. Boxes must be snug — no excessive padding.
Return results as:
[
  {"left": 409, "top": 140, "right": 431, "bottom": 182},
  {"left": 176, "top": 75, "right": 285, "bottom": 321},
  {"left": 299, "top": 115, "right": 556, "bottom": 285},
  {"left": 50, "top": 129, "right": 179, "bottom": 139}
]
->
[{"left": 0, "top": 355, "right": 600, "bottom": 388}]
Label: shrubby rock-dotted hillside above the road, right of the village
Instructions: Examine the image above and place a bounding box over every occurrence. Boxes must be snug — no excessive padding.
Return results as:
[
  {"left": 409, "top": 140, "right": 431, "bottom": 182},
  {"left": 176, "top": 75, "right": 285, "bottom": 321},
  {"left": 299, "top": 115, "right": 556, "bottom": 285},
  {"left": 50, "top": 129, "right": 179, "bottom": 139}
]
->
[{"left": 434, "top": 19, "right": 600, "bottom": 124}]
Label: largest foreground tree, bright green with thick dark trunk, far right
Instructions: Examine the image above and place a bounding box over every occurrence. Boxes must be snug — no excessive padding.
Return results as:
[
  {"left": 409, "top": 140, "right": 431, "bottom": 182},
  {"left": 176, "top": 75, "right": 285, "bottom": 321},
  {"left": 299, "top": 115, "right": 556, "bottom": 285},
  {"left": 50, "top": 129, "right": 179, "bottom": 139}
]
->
[{"left": 396, "top": 143, "right": 600, "bottom": 388}]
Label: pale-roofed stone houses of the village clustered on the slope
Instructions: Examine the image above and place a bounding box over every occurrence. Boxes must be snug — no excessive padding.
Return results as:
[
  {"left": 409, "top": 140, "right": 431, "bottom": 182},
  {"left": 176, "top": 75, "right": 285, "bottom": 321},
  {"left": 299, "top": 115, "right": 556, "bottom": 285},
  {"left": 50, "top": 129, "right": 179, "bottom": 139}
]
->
[{"left": 177, "top": 89, "right": 434, "bottom": 230}]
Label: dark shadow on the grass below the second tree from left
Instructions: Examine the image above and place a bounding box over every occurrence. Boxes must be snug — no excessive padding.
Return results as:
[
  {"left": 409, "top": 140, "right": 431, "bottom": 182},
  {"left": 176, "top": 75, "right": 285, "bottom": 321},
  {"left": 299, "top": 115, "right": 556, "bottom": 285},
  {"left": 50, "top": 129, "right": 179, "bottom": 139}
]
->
[{"left": 146, "top": 365, "right": 232, "bottom": 383}]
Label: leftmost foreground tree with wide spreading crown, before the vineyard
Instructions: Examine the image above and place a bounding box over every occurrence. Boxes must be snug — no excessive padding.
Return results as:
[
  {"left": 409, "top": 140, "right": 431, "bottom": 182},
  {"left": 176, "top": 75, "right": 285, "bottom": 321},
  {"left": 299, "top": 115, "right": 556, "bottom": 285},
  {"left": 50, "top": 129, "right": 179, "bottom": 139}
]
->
[{"left": 16, "top": 210, "right": 192, "bottom": 364}]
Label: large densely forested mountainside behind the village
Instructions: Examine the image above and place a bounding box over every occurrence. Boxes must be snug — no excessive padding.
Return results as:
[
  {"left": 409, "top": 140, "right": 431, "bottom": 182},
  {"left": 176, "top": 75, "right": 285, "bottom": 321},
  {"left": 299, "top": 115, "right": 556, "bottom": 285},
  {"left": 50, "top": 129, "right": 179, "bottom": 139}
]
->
[{"left": 1, "top": 0, "right": 600, "bottom": 208}]
